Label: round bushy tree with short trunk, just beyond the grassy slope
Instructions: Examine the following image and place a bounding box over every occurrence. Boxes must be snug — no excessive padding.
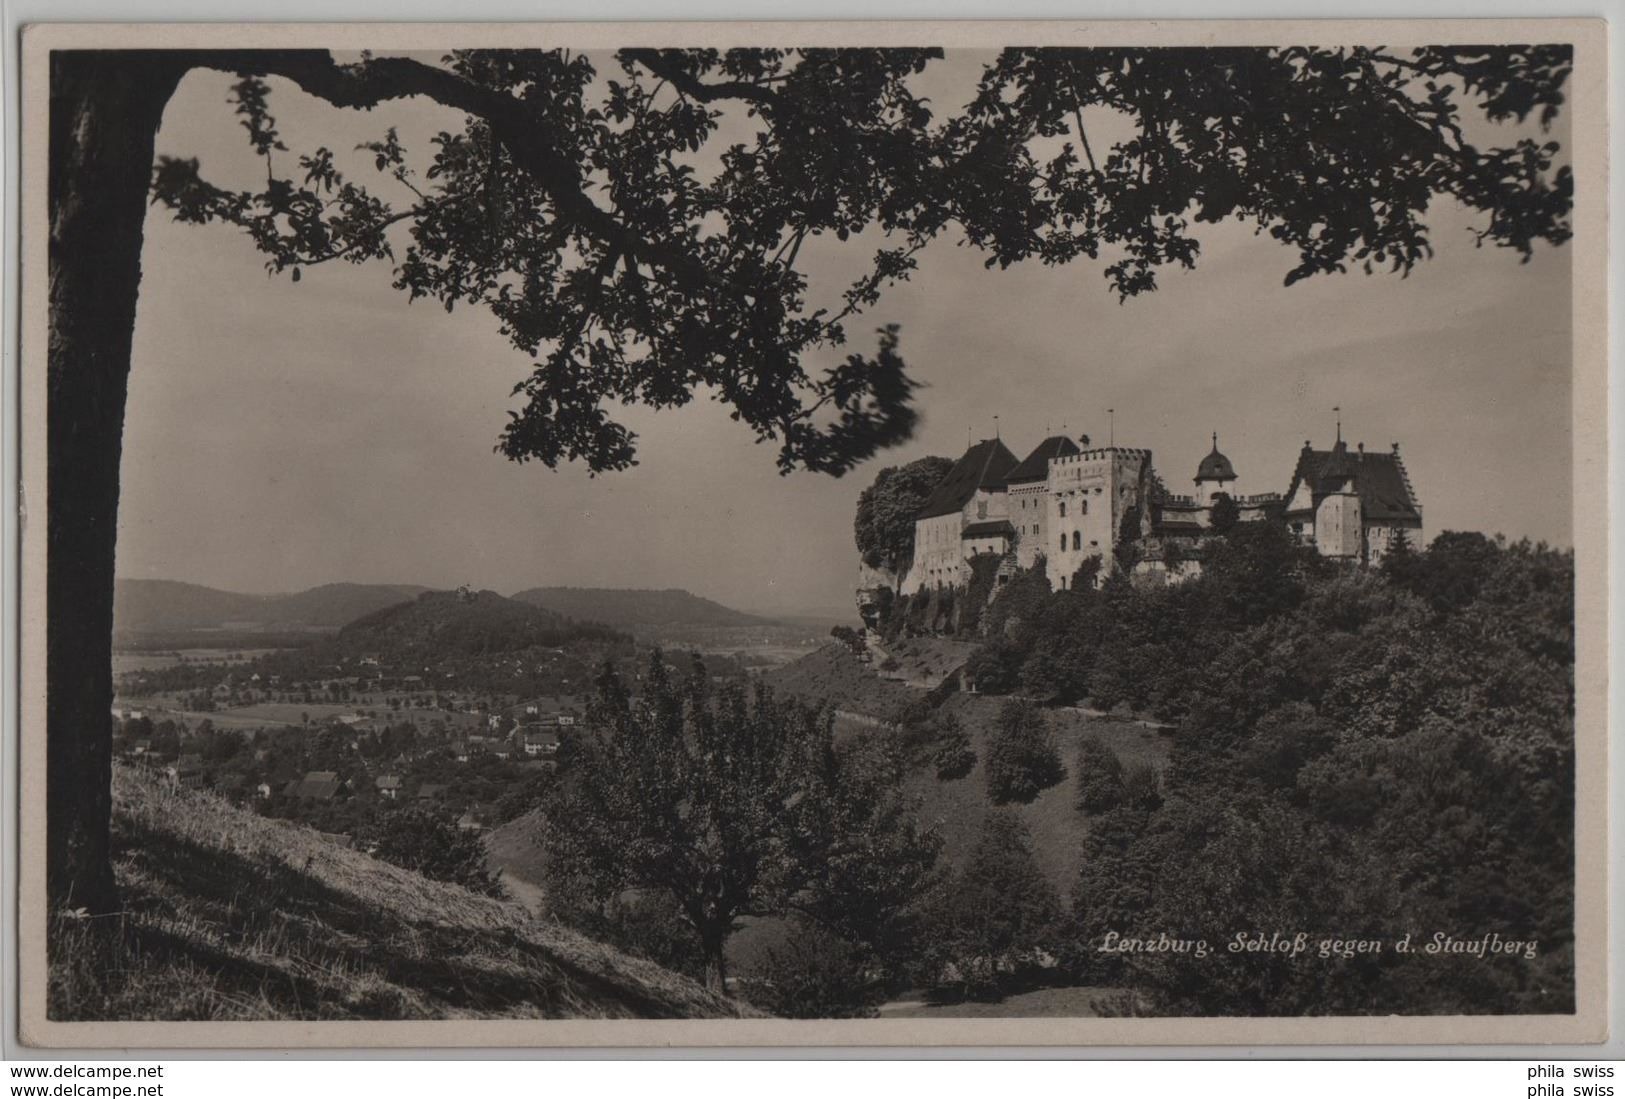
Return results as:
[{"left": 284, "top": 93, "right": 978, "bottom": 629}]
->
[{"left": 546, "top": 652, "right": 939, "bottom": 990}]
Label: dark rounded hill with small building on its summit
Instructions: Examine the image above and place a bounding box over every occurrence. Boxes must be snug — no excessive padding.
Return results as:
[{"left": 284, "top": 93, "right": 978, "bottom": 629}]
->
[{"left": 336, "top": 589, "right": 614, "bottom": 660}]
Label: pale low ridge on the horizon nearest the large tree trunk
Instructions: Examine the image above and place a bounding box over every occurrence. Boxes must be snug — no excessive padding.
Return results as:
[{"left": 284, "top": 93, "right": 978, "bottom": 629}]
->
[{"left": 112, "top": 580, "right": 427, "bottom": 634}]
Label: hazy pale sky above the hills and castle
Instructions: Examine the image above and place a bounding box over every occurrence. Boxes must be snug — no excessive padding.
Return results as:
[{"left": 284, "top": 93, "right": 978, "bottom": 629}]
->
[{"left": 117, "top": 55, "right": 1573, "bottom": 613}]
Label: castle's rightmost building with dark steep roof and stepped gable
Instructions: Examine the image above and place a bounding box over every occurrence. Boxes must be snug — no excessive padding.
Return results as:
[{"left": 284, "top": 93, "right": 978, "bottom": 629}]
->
[{"left": 1282, "top": 431, "right": 1424, "bottom": 564}]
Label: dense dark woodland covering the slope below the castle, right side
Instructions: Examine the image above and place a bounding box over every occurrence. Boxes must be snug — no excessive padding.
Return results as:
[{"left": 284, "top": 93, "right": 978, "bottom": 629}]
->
[{"left": 949, "top": 523, "right": 1575, "bottom": 1014}]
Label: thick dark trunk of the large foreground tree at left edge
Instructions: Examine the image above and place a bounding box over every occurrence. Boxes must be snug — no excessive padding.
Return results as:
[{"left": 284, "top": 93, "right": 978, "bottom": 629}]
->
[{"left": 46, "top": 50, "right": 187, "bottom": 912}]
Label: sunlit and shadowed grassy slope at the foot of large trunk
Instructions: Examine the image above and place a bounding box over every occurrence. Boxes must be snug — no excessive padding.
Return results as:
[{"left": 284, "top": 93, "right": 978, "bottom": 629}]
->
[{"left": 50, "top": 767, "right": 754, "bottom": 1019}]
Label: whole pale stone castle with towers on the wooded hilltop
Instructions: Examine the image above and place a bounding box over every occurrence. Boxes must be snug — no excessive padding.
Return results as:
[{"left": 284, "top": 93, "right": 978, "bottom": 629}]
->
[{"left": 895, "top": 428, "right": 1422, "bottom": 595}]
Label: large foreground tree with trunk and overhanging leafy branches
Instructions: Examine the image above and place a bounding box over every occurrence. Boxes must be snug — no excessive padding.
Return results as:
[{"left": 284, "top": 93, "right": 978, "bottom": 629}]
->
[{"left": 47, "top": 46, "right": 1573, "bottom": 910}]
